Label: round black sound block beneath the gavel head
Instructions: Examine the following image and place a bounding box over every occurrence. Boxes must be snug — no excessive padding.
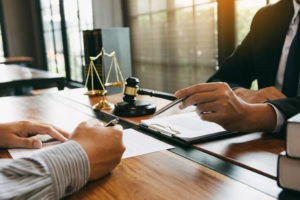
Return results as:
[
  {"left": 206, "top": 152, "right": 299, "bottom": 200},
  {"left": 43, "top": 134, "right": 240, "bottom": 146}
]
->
[{"left": 113, "top": 101, "right": 156, "bottom": 117}]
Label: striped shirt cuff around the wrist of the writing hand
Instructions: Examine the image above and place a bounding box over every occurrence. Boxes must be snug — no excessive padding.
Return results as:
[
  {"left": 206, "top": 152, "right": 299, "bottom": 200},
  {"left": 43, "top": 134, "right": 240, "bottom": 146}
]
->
[{"left": 35, "top": 140, "right": 90, "bottom": 199}]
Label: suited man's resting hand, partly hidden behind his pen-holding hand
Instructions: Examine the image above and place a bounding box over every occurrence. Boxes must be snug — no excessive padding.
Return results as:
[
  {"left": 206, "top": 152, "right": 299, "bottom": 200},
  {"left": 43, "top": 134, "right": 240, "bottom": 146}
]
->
[{"left": 234, "top": 87, "right": 286, "bottom": 103}]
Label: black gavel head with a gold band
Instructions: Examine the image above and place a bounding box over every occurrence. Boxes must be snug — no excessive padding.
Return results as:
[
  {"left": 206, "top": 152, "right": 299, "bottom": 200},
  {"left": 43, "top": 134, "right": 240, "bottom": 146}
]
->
[{"left": 123, "top": 77, "right": 140, "bottom": 103}]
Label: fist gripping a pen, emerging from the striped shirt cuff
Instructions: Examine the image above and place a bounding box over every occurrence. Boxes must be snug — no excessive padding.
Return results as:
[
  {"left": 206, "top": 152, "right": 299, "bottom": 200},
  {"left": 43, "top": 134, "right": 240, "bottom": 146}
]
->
[{"left": 71, "top": 120, "right": 125, "bottom": 180}]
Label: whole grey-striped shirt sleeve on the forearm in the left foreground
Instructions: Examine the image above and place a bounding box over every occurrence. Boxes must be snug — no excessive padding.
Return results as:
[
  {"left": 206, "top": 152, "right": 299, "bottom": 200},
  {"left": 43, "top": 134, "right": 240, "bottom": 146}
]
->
[{"left": 0, "top": 141, "right": 89, "bottom": 199}]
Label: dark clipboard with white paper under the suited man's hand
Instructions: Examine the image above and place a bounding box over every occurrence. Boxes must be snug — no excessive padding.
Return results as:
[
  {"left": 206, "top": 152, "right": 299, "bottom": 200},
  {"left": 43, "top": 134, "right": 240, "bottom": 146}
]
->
[{"left": 139, "top": 111, "right": 238, "bottom": 145}]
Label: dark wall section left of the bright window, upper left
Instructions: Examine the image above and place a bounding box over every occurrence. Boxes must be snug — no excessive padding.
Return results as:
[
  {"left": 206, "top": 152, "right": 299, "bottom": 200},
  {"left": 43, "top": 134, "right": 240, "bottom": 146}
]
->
[{"left": 2, "top": 0, "right": 45, "bottom": 69}]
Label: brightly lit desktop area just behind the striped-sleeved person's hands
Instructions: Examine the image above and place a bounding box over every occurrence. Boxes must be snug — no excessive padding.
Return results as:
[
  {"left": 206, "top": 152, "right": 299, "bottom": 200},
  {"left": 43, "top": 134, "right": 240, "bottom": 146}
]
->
[{"left": 0, "top": 96, "right": 93, "bottom": 132}]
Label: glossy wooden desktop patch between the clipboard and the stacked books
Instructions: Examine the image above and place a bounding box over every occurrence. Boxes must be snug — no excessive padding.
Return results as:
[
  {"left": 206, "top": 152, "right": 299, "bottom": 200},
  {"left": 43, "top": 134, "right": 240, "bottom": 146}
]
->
[{"left": 194, "top": 133, "right": 285, "bottom": 179}]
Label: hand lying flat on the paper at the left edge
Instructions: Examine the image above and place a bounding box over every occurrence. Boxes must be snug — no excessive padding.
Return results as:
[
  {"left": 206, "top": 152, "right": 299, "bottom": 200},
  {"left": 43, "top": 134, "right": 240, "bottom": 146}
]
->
[{"left": 0, "top": 121, "right": 69, "bottom": 149}]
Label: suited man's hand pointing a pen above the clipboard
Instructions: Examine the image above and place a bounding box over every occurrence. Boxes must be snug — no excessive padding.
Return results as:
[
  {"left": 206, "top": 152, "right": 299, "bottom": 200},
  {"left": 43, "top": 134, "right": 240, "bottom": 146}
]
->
[{"left": 175, "top": 83, "right": 276, "bottom": 132}]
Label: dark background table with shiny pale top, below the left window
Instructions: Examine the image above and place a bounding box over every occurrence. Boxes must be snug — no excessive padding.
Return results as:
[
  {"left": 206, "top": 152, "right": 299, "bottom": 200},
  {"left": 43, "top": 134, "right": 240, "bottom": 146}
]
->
[{"left": 0, "top": 64, "right": 65, "bottom": 94}]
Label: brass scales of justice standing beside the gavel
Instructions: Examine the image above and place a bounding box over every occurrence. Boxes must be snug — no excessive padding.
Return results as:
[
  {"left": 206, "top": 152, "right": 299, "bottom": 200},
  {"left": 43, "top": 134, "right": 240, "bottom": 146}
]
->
[{"left": 85, "top": 48, "right": 125, "bottom": 110}]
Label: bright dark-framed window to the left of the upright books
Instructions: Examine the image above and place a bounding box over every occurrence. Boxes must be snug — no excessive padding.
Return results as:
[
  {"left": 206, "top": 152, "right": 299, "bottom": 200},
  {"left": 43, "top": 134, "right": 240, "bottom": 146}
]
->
[{"left": 40, "top": 0, "right": 93, "bottom": 83}]
